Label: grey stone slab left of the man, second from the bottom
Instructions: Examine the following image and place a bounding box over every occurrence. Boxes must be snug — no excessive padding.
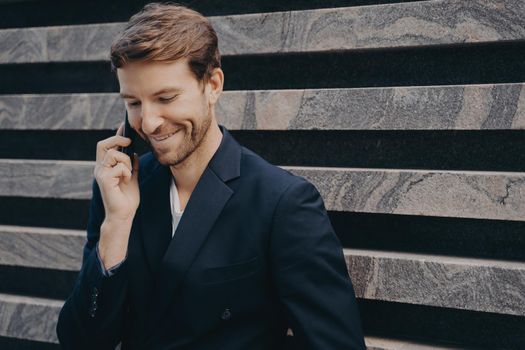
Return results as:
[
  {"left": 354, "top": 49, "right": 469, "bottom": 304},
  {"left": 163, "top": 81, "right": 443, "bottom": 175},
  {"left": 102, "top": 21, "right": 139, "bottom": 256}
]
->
[{"left": 0, "top": 226, "right": 86, "bottom": 271}]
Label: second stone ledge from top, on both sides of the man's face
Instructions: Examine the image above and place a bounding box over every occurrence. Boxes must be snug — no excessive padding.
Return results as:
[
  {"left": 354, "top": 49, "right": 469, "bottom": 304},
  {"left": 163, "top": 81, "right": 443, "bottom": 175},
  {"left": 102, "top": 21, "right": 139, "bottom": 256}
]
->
[{"left": 0, "top": 84, "right": 525, "bottom": 130}]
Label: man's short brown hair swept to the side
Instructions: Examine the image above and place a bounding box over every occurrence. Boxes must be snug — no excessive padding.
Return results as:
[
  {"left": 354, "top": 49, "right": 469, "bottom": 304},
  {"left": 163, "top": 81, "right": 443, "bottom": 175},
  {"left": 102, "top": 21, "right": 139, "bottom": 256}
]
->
[{"left": 110, "top": 3, "right": 221, "bottom": 82}]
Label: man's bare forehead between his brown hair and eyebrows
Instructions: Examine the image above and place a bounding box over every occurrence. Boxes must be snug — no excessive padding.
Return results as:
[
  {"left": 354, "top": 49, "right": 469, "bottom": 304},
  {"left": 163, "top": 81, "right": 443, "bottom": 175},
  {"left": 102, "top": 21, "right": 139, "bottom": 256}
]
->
[{"left": 117, "top": 59, "right": 198, "bottom": 96}]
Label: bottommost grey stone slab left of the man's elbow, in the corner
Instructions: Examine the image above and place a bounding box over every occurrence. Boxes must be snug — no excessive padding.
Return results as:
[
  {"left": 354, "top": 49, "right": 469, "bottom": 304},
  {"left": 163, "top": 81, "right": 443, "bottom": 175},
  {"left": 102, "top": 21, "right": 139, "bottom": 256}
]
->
[{"left": 0, "top": 294, "right": 63, "bottom": 343}]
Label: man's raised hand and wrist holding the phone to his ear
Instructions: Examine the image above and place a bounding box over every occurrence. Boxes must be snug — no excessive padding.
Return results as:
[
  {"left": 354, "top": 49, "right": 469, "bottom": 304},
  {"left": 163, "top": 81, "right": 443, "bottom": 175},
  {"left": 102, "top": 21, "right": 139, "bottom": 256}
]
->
[{"left": 94, "top": 123, "right": 140, "bottom": 269}]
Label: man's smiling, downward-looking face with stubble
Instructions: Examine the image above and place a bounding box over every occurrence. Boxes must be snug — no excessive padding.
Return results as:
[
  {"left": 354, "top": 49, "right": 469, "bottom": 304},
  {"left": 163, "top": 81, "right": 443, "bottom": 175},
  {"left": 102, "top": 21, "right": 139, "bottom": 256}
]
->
[{"left": 117, "top": 60, "right": 213, "bottom": 166}]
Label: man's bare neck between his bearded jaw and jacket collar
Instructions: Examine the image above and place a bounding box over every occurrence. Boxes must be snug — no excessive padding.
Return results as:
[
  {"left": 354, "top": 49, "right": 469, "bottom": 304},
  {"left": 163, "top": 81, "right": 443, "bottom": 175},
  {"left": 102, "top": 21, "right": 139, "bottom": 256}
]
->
[{"left": 170, "top": 122, "right": 222, "bottom": 194}]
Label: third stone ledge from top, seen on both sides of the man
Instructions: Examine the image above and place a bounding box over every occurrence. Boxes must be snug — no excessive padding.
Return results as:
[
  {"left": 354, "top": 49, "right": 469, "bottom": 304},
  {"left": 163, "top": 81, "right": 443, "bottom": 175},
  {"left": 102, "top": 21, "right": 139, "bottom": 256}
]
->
[{"left": 0, "top": 159, "right": 525, "bottom": 221}]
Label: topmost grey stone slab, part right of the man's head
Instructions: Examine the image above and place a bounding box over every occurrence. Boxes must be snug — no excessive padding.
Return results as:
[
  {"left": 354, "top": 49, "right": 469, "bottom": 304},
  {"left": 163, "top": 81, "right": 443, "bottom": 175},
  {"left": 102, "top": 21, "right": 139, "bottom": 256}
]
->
[{"left": 213, "top": 0, "right": 525, "bottom": 54}]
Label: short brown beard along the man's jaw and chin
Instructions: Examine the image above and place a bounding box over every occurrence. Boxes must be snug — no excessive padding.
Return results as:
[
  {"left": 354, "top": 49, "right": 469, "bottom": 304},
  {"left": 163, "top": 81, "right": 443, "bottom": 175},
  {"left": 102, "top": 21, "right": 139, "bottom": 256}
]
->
[{"left": 146, "top": 111, "right": 212, "bottom": 166}]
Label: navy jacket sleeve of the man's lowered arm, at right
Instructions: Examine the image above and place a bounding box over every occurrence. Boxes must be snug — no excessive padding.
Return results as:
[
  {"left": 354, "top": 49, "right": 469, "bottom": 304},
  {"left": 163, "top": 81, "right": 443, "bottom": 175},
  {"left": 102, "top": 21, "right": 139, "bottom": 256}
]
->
[{"left": 271, "top": 180, "right": 365, "bottom": 350}]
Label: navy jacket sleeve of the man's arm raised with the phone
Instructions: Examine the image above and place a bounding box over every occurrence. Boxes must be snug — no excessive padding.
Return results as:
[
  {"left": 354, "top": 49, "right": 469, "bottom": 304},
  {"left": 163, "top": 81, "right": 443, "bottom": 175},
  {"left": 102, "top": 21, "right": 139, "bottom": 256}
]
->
[{"left": 57, "top": 182, "right": 127, "bottom": 349}]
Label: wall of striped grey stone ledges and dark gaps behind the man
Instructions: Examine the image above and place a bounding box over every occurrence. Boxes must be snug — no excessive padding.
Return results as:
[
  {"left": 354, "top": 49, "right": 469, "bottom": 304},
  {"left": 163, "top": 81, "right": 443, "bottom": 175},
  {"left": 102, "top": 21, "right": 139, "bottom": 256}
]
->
[{"left": 0, "top": 0, "right": 525, "bottom": 350}]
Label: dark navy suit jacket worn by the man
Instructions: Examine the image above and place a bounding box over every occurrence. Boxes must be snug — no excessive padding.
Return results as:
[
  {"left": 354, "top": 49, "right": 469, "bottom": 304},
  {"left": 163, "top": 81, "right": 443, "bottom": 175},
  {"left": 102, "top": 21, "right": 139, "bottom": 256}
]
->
[{"left": 57, "top": 127, "right": 365, "bottom": 350}]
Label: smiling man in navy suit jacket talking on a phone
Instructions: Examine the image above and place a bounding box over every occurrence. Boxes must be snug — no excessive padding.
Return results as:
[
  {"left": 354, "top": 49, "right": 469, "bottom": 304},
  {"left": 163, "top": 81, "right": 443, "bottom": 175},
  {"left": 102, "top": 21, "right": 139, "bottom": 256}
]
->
[{"left": 57, "top": 4, "right": 365, "bottom": 350}]
